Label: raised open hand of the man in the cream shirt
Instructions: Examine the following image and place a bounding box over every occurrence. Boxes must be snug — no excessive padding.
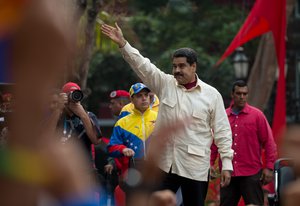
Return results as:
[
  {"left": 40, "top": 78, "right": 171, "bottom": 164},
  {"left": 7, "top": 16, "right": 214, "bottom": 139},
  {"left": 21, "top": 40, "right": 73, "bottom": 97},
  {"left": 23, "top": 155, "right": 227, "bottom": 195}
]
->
[{"left": 101, "top": 23, "right": 126, "bottom": 48}]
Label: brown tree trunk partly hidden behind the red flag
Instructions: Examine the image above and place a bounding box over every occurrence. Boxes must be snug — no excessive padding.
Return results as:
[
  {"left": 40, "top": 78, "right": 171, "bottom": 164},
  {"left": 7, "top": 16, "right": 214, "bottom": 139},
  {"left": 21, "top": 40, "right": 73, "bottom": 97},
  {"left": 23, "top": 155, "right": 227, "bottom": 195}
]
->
[{"left": 248, "top": 0, "right": 296, "bottom": 111}]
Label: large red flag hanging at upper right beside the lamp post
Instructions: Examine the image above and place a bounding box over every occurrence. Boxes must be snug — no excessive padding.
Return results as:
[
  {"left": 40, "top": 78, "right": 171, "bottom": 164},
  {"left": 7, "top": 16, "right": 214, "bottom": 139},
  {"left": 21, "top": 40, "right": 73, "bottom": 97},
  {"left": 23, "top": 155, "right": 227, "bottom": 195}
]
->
[{"left": 217, "top": 0, "right": 286, "bottom": 142}]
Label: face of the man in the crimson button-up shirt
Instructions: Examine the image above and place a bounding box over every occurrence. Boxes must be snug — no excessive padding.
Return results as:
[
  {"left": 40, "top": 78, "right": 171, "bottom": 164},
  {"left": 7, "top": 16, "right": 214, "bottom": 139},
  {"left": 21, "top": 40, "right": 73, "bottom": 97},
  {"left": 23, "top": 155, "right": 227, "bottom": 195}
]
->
[{"left": 231, "top": 86, "right": 248, "bottom": 109}]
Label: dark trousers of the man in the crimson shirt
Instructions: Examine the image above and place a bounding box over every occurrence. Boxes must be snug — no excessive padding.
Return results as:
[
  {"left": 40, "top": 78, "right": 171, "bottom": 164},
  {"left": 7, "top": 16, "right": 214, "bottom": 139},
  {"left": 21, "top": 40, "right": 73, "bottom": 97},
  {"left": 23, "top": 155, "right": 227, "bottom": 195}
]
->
[{"left": 220, "top": 171, "right": 264, "bottom": 206}]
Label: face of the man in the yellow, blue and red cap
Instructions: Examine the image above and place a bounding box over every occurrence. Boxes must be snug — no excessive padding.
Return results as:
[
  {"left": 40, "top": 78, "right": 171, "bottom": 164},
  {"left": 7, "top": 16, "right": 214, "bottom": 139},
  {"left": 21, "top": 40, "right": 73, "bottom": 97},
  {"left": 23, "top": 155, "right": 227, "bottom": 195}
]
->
[{"left": 131, "top": 89, "right": 150, "bottom": 112}]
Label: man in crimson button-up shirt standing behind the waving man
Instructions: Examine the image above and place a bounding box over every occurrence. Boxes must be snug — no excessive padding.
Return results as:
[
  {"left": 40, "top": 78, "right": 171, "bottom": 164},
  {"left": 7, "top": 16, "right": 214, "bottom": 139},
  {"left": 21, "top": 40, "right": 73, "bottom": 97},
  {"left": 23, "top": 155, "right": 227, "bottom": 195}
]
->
[{"left": 211, "top": 80, "right": 277, "bottom": 206}]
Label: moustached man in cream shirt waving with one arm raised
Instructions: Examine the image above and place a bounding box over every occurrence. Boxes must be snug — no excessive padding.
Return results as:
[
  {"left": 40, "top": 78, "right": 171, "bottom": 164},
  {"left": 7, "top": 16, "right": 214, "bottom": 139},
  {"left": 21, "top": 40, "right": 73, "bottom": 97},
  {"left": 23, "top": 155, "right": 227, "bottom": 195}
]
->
[{"left": 101, "top": 24, "right": 233, "bottom": 206}]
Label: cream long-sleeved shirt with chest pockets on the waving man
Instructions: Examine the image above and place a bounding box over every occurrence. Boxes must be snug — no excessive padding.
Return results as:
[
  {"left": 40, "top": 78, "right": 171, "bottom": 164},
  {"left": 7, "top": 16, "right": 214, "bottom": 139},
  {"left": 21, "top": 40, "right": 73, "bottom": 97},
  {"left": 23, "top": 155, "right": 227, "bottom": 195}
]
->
[{"left": 120, "top": 43, "right": 233, "bottom": 181}]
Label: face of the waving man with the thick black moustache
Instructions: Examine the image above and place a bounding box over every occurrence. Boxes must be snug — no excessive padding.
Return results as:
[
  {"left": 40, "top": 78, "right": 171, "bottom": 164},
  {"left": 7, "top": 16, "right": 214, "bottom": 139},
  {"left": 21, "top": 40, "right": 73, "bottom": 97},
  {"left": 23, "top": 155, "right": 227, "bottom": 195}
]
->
[{"left": 173, "top": 57, "right": 196, "bottom": 85}]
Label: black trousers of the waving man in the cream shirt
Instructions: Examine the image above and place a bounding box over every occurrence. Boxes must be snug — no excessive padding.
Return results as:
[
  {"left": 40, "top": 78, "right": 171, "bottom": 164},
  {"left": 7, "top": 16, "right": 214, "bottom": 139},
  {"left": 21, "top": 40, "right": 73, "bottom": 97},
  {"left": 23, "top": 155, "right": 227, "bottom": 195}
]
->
[{"left": 159, "top": 171, "right": 208, "bottom": 206}]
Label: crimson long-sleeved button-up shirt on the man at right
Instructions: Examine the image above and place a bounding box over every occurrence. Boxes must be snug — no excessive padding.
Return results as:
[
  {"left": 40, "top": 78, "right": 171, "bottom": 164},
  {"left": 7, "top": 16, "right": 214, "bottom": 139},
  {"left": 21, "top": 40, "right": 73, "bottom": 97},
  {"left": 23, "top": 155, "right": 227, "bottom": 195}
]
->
[{"left": 226, "top": 104, "right": 277, "bottom": 176}]
